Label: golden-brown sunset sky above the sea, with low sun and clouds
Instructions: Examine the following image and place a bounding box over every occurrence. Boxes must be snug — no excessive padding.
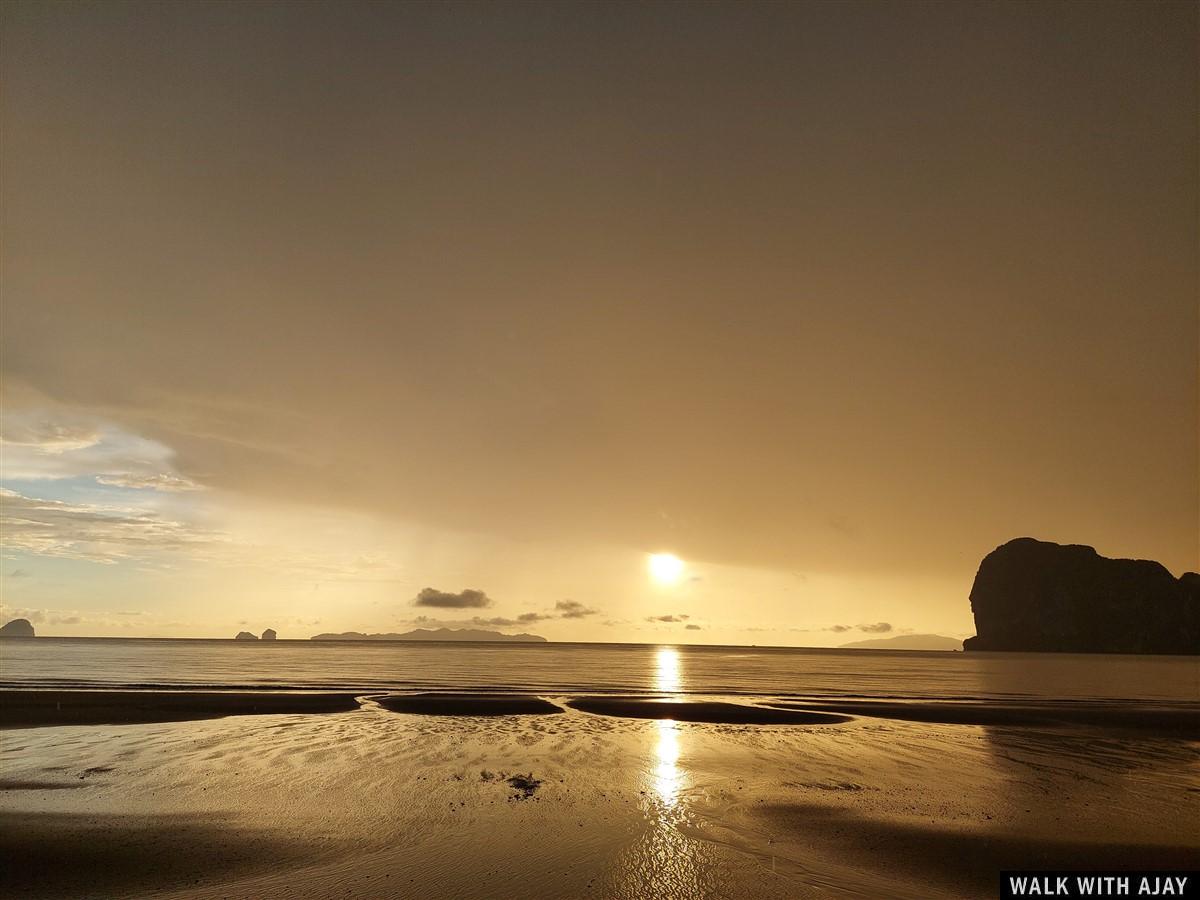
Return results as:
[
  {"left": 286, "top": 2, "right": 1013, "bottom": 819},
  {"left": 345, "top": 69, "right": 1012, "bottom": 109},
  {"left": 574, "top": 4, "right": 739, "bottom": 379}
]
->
[{"left": 0, "top": 1, "right": 1200, "bottom": 647}]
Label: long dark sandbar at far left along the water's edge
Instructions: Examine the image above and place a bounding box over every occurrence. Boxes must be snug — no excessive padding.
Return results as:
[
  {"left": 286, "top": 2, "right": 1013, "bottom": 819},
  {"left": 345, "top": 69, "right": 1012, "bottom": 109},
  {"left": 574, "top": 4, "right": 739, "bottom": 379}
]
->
[{"left": 0, "top": 690, "right": 359, "bottom": 728}]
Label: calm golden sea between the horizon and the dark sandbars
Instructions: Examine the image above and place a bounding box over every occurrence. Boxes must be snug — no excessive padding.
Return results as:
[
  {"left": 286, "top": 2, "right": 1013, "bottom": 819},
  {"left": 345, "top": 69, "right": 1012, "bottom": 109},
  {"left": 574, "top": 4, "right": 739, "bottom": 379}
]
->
[{"left": 0, "top": 637, "right": 1200, "bottom": 701}]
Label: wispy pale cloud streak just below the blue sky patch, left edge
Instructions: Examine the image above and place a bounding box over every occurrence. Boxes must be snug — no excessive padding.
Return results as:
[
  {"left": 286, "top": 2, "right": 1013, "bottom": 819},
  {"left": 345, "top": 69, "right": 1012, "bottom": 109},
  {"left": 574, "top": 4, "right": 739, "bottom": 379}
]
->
[{"left": 0, "top": 488, "right": 223, "bottom": 563}]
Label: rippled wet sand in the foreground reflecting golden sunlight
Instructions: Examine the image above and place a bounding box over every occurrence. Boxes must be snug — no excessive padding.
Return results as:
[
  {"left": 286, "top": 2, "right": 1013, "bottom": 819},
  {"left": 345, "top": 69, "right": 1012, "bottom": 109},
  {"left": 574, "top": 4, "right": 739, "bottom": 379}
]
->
[{"left": 0, "top": 695, "right": 1200, "bottom": 900}]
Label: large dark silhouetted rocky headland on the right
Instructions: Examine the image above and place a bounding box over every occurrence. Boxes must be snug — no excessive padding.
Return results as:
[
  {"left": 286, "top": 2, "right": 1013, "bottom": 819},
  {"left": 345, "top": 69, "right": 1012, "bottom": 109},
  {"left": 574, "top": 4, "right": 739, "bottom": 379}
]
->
[{"left": 964, "top": 538, "right": 1200, "bottom": 654}]
